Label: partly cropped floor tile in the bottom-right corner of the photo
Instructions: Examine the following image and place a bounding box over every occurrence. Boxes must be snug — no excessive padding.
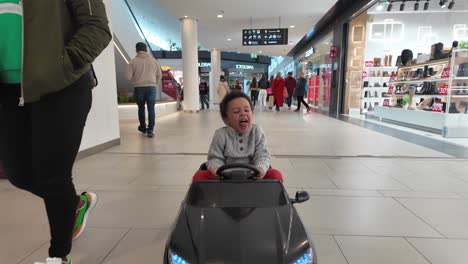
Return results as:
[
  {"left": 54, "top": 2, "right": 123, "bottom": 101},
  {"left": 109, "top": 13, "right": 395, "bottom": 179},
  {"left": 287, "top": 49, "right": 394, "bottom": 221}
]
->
[{"left": 408, "top": 238, "right": 468, "bottom": 264}]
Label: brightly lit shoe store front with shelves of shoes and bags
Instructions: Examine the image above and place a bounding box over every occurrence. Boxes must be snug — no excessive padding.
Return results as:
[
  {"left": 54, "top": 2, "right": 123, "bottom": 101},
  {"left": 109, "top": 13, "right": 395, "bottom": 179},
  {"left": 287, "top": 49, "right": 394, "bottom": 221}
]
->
[{"left": 343, "top": 0, "right": 468, "bottom": 137}]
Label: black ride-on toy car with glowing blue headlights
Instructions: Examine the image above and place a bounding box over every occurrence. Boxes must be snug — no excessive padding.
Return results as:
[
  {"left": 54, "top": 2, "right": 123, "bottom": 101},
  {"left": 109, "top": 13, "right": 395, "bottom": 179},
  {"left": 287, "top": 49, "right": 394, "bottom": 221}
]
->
[{"left": 164, "top": 164, "right": 317, "bottom": 264}]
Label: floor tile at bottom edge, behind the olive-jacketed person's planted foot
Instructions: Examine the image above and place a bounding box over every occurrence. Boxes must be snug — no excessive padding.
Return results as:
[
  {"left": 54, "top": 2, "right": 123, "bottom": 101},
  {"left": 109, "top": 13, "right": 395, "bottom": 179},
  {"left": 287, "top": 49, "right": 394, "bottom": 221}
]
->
[{"left": 20, "top": 228, "right": 128, "bottom": 264}]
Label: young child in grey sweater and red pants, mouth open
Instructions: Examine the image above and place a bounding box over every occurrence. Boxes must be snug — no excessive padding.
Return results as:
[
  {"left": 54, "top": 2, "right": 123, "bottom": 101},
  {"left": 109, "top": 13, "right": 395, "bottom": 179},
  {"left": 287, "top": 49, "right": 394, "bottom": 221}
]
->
[{"left": 193, "top": 91, "right": 283, "bottom": 181}]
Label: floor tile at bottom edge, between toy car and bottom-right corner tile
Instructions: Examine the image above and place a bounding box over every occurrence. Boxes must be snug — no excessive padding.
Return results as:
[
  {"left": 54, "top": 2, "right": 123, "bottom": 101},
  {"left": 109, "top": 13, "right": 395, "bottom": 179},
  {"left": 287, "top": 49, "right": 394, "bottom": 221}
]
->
[{"left": 336, "top": 236, "right": 430, "bottom": 264}]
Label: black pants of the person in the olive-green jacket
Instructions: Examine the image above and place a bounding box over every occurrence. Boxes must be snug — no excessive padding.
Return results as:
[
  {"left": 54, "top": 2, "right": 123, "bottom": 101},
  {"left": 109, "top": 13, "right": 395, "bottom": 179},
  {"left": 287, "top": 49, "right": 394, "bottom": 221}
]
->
[{"left": 0, "top": 74, "right": 92, "bottom": 257}]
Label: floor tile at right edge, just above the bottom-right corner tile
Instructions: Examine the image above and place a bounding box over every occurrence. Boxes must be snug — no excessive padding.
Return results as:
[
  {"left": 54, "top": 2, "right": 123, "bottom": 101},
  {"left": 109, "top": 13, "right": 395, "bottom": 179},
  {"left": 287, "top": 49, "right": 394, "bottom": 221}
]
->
[{"left": 398, "top": 198, "right": 468, "bottom": 239}]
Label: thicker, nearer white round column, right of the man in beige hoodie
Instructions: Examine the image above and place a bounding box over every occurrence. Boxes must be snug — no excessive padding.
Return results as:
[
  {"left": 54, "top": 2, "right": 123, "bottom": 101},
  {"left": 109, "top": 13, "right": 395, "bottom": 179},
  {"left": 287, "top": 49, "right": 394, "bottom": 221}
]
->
[{"left": 180, "top": 18, "right": 200, "bottom": 111}]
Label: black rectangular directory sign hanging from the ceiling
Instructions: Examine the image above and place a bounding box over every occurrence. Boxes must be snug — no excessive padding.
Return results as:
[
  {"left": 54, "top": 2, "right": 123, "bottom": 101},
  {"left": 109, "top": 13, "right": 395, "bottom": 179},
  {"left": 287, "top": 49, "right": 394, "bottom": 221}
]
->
[{"left": 242, "top": 28, "right": 288, "bottom": 46}]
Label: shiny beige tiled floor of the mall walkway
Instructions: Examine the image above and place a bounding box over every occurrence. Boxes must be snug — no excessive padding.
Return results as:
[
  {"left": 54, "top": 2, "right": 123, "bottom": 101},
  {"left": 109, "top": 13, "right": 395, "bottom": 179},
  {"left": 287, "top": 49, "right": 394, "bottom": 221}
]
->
[{"left": 0, "top": 108, "right": 468, "bottom": 264}]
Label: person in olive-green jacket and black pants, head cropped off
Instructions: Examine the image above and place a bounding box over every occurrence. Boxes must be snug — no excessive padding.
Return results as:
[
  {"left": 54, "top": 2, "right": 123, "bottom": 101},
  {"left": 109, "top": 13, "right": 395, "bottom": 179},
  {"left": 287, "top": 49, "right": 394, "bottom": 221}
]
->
[{"left": 0, "top": 0, "right": 112, "bottom": 264}]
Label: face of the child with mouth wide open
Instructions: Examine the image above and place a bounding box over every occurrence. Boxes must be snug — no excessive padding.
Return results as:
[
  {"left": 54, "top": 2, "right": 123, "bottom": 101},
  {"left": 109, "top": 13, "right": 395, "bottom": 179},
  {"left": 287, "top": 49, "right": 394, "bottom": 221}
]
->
[{"left": 224, "top": 98, "right": 253, "bottom": 134}]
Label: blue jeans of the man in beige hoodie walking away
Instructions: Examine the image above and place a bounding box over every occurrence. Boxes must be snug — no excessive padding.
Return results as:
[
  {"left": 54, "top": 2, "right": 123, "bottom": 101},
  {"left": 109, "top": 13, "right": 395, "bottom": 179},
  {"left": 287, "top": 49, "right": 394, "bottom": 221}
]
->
[{"left": 133, "top": 86, "right": 156, "bottom": 131}]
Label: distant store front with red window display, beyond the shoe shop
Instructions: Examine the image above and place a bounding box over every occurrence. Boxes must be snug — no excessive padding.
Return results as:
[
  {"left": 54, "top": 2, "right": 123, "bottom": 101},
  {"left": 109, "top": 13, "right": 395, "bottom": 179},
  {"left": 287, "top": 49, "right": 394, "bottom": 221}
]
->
[{"left": 297, "top": 33, "right": 336, "bottom": 113}]
